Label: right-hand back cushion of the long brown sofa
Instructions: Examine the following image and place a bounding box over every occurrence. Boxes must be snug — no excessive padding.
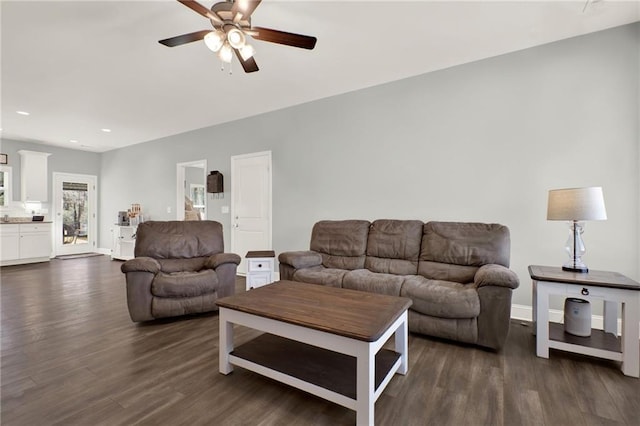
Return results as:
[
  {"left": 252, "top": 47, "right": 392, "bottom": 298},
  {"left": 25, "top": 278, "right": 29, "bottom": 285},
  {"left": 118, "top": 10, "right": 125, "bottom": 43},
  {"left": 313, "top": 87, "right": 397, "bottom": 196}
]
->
[{"left": 418, "top": 222, "right": 511, "bottom": 283}]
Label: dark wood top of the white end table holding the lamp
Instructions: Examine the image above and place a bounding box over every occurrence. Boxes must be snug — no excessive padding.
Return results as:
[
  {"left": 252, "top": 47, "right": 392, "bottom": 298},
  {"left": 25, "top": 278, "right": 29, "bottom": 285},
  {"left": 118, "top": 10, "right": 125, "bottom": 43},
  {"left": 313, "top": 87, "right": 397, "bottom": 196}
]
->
[{"left": 529, "top": 265, "right": 640, "bottom": 291}]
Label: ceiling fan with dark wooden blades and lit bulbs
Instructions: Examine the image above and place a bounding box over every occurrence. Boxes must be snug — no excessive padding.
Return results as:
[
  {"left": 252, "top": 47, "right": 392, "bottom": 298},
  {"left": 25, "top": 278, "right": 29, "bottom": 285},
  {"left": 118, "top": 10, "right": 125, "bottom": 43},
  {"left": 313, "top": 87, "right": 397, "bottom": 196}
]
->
[{"left": 158, "top": 0, "right": 317, "bottom": 73}]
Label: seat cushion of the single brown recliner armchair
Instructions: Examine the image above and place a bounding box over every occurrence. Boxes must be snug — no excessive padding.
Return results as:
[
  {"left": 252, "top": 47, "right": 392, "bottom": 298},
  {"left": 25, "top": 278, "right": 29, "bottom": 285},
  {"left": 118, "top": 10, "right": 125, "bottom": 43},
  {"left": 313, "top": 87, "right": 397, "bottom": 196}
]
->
[{"left": 151, "top": 269, "right": 218, "bottom": 297}]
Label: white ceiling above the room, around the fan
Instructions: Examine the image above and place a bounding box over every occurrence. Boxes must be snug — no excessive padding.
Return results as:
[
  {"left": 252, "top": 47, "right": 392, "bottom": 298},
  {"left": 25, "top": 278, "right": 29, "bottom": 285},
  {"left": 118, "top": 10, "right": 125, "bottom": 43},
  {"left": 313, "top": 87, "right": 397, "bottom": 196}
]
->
[{"left": 0, "top": 0, "right": 640, "bottom": 152}]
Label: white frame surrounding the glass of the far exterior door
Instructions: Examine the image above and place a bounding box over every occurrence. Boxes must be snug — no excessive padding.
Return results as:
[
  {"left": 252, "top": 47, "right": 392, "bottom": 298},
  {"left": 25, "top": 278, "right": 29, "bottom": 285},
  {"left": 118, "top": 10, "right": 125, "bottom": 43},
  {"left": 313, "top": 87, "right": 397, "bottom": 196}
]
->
[{"left": 51, "top": 172, "right": 98, "bottom": 256}]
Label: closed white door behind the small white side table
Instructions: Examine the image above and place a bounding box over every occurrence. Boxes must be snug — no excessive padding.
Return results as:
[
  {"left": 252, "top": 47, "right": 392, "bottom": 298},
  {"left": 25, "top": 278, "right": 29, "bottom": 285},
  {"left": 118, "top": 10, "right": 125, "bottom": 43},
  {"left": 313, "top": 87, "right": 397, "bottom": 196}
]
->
[{"left": 231, "top": 151, "right": 272, "bottom": 275}]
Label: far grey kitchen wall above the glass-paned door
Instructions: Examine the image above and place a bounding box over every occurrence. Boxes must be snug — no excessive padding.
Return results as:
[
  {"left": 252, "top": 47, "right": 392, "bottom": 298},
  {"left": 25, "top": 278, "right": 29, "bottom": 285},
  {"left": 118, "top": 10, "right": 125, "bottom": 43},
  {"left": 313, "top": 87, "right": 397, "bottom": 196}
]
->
[{"left": 0, "top": 139, "right": 100, "bottom": 212}]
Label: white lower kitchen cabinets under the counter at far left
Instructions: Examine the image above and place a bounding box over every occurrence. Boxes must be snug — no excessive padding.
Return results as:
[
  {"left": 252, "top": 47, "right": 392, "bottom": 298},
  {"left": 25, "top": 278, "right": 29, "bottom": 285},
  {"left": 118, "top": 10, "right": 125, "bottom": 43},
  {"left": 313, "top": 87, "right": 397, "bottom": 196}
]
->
[{"left": 0, "top": 222, "right": 51, "bottom": 266}]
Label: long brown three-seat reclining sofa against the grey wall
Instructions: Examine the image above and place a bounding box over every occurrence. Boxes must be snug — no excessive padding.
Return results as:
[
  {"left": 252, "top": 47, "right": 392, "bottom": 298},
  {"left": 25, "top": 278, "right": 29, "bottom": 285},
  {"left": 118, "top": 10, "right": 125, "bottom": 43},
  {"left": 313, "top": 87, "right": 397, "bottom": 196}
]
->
[{"left": 278, "top": 219, "right": 519, "bottom": 350}]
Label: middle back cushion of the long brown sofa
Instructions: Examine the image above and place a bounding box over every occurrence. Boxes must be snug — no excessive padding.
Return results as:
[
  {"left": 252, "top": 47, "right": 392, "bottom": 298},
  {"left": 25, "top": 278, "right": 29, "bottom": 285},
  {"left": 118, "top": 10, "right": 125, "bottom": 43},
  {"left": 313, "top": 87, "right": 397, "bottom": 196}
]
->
[{"left": 364, "top": 219, "right": 424, "bottom": 275}]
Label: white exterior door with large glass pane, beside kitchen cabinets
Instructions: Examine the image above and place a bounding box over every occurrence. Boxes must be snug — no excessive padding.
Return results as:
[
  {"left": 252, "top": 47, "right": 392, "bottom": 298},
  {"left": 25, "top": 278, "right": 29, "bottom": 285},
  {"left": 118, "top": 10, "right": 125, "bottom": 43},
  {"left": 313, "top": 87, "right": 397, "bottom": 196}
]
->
[{"left": 53, "top": 173, "right": 98, "bottom": 256}]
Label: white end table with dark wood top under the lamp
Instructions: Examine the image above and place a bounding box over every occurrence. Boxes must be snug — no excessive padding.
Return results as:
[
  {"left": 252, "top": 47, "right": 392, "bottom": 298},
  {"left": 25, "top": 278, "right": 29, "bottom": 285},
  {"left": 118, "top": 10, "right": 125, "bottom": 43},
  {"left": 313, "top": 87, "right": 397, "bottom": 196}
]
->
[{"left": 529, "top": 265, "right": 640, "bottom": 377}]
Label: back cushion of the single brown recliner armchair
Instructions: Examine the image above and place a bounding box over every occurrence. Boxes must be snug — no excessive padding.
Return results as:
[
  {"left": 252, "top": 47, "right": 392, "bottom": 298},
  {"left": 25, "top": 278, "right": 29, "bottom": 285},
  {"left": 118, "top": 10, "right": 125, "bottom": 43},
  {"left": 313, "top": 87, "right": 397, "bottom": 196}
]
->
[{"left": 134, "top": 220, "right": 224, "bottom": 259}]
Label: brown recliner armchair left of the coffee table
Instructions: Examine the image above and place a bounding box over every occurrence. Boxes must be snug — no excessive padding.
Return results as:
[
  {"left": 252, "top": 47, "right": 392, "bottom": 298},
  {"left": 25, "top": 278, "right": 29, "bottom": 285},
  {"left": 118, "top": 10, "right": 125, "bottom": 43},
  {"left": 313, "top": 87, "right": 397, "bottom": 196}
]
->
[{"left": 121, "top": 220, "right": 240, "bottom": 322}]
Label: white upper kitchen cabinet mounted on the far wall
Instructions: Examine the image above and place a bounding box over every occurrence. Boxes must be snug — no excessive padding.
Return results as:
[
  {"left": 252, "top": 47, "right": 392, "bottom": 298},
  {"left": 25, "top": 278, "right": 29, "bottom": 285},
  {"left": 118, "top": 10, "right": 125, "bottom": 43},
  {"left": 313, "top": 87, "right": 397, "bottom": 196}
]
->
[{"left": 18, "top": 150, "right": 51, "bottom": 202}]
